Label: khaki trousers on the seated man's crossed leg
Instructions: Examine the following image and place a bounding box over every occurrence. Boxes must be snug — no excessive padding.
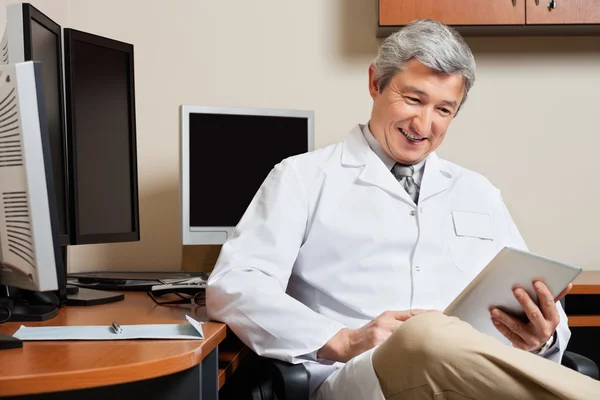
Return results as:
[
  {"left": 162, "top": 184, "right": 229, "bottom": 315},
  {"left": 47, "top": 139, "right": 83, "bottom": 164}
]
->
[{"left": 372, "top": 312, "right": 600, "bottom": 400}]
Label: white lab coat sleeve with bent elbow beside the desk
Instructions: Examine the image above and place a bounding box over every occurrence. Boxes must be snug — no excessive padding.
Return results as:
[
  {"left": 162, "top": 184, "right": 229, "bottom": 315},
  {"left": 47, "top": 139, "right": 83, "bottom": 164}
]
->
[{"left": 206, "top": 160, "right": 345, "bottom": 363}]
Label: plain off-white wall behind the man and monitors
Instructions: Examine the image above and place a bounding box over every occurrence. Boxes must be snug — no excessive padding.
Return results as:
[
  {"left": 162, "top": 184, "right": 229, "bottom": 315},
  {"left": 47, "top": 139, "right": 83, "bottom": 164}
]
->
[{"left": 0, "top": 0, "right": 600, "bottom": 271}]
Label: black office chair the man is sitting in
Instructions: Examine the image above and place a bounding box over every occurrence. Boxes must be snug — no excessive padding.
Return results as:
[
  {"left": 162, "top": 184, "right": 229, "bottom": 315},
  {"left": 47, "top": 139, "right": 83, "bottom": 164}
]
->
[{"left": 252, "top": 299, "right": 600, "bottom": 400}]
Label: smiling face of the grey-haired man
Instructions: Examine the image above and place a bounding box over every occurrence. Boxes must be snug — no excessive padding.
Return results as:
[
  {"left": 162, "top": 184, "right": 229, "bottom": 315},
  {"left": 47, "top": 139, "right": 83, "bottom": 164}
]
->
[{"left": 369, "top": 59, "right": 465, "bottom": 164}]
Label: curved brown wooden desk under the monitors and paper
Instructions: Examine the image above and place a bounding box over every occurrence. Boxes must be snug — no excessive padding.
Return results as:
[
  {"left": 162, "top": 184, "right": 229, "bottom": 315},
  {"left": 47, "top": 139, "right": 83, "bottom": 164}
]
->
[{"left": 0, "top": 292, "right": 243, "bottom": 399}]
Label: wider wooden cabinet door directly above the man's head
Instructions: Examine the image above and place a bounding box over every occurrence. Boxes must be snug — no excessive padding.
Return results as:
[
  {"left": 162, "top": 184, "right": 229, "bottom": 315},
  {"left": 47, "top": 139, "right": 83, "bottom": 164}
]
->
[{"left": 379, "top": 0, "right": 524, "bottom": 26}]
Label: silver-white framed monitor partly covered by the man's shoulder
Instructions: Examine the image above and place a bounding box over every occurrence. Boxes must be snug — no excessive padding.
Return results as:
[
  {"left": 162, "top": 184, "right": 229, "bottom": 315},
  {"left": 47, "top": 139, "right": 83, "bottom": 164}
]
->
[{"left": 180, "top": 105, "right": 314, "bottom": 245}]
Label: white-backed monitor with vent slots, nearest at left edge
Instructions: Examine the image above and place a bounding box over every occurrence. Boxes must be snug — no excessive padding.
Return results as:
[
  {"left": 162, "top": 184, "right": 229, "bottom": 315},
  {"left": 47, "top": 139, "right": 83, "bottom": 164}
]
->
[{"left": 0, "top": 62, "right": 66, "bottom": 292}]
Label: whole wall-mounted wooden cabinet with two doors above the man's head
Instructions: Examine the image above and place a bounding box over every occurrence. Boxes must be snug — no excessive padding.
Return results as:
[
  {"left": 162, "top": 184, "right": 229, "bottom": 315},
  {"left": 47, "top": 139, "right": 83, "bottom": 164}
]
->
[{"left": 377, "top": 0, "right": 600, "bottom": 37}]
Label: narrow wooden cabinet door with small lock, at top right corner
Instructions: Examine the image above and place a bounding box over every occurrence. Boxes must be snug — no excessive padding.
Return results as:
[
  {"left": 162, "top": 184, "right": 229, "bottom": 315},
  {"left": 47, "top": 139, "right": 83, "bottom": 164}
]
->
[{"left": 526, "top": 0, "right": 600, "bottom": 25}]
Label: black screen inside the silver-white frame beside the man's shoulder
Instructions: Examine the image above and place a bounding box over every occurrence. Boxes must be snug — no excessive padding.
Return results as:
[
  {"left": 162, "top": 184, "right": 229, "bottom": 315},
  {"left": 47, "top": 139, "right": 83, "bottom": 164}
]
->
[{"left": 189, "top": 113, "right": 308, "bottom": 227}]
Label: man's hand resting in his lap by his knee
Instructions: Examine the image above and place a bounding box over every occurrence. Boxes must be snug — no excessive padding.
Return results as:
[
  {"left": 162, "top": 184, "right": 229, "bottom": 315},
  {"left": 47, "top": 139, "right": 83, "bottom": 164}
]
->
[{"left": 317, "top": 310, "right": 435, "bottom": 362}]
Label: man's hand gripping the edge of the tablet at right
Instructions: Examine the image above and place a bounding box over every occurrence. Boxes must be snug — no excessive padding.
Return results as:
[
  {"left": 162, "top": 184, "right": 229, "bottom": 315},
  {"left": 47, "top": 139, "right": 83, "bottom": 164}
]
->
[{"left": 491, "top": 281, "right": 573, "bottom": 351}]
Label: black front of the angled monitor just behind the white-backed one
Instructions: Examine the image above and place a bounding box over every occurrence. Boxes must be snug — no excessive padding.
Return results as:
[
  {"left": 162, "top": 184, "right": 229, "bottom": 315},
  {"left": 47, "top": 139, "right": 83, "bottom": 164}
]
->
[{"left": 25, "top": 7, "right": 69, "bottom": 245}]
